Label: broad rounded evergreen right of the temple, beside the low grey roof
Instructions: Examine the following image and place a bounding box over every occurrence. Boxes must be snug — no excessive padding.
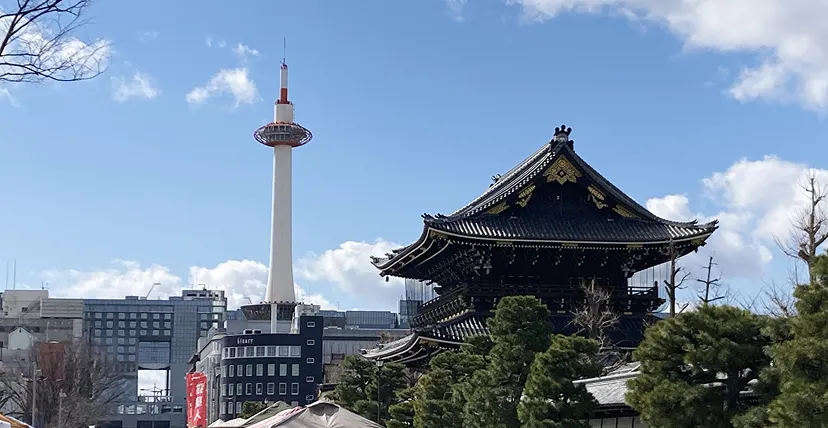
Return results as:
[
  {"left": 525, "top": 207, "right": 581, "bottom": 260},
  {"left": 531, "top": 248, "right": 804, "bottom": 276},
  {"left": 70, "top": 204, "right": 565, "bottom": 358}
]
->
[{"left": 626, "top": 306, "right": 770, "bottom": 428}]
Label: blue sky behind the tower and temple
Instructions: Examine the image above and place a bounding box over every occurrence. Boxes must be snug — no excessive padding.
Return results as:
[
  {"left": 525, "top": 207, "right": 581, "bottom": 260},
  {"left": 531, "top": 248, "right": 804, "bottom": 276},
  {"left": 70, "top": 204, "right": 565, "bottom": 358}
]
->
[{"left": 0, "top": 0, "right": 828, "bottom": 309}]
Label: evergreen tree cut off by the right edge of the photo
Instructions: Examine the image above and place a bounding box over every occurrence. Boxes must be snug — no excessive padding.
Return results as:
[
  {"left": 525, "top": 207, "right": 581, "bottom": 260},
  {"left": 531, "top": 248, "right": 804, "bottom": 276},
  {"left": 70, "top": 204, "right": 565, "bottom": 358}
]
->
[{"left": 767, "top": 255, "right": 828, "bottom": 428}]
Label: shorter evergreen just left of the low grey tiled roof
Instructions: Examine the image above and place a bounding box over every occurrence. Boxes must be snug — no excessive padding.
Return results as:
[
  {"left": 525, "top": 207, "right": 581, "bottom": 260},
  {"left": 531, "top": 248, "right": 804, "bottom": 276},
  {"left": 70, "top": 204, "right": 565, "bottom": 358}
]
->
[{"left": 518, "top": 335, "right": 603, "bottom": 428}]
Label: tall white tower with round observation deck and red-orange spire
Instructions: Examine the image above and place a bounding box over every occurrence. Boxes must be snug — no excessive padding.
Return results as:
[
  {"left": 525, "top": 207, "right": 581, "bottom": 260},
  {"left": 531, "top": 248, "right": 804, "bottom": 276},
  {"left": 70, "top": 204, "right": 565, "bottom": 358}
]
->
[{"left": 253, "top": 59, "right": 313, "bottom": 333}]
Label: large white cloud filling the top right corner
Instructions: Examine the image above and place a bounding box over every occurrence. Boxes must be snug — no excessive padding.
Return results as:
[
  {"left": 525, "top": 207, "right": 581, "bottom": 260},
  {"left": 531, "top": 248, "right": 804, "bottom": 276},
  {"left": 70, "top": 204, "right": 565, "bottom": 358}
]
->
[{"left": 506, "top": 0, "right": 828, "bottom": 110}]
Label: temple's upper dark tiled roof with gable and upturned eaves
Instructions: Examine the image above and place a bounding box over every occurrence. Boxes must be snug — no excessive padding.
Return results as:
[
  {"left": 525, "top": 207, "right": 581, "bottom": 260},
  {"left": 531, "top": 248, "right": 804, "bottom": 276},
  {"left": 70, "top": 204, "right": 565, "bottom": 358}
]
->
[{"left": 372, "top": 127, "right": 717, "bottom": 269}]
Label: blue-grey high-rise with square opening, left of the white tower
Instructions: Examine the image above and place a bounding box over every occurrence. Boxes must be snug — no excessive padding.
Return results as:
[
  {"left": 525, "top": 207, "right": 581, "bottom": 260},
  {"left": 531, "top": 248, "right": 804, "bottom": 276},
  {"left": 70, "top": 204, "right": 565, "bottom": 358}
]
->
[{"left": 83, "top": 290, "right": 227, "bottom": 428}]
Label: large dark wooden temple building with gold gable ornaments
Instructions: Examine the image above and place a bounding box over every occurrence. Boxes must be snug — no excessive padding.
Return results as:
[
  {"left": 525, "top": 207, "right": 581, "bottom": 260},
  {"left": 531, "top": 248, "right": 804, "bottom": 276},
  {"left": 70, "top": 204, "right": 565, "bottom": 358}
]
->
[{"left": 363, "top": 126, "right": 717, "bottom": 365}]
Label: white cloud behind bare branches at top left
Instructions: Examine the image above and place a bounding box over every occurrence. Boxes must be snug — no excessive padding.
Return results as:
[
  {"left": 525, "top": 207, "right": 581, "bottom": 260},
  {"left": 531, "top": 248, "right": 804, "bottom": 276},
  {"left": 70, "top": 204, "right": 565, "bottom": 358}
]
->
[{"left": 0, "top": 8, "right": 112, "bottom": 81}]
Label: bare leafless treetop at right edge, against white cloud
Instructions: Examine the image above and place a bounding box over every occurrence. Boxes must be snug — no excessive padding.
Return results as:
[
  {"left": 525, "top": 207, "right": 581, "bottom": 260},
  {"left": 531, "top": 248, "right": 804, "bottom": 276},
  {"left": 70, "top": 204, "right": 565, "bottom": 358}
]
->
[{"left": 774, "top": 171, "right": 828, "bottom": 284}]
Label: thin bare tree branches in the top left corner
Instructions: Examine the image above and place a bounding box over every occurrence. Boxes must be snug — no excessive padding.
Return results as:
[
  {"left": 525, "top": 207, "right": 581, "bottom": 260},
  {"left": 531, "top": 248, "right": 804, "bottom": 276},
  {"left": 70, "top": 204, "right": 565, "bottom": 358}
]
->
[{"left": 0, "top": 0, "right": 111, "bottom": 83}]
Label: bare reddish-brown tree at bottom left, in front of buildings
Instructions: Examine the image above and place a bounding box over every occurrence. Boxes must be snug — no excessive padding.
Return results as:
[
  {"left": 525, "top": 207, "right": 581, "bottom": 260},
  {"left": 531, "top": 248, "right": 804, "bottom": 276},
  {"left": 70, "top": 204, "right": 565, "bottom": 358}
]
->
[{"left": 0, "top": 340, "right": 126, "bottom": 428}]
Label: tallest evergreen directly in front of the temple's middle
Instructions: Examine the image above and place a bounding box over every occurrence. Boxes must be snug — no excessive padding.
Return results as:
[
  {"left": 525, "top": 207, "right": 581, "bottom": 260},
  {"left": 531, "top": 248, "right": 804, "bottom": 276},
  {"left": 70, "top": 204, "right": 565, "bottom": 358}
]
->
[{"left": 459, "top": 296, "right": 552, "bottom": 428}]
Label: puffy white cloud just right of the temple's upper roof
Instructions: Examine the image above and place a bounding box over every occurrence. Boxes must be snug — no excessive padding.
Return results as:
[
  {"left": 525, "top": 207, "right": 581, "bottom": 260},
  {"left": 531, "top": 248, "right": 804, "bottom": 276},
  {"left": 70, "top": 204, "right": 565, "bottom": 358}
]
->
[{"left": 646, "top": 156, "right": 828, "bottom": 279}]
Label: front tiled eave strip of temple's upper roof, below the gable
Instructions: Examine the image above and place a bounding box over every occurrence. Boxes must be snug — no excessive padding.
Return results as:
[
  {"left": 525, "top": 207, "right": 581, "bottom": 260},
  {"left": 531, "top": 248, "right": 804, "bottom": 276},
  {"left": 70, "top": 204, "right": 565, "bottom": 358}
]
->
[{"left": 426, "top": 216, "right": 710, "bottom": 242}]
